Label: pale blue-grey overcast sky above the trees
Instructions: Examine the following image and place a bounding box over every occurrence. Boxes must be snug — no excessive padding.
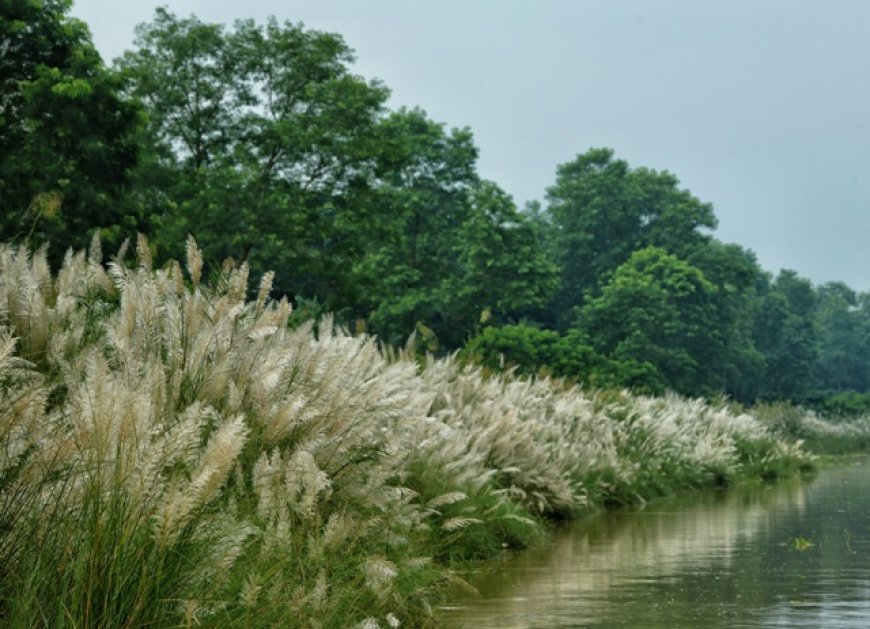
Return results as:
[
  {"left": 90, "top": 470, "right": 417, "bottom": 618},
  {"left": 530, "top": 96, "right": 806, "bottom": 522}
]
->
[{"left": 72, "top": 0, "right": 870, "bottom": 291}]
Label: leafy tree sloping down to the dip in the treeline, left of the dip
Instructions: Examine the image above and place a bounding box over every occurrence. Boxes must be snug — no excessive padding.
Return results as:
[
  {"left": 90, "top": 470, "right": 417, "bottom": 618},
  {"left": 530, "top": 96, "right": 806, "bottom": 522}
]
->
[{"left": 361, "top": 115, "right": 556, "bottom": 348}]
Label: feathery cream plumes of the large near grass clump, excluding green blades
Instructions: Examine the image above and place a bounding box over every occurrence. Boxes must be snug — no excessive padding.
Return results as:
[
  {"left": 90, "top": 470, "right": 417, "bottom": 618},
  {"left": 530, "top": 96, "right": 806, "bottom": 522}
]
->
[{"left": 0, "top": 239, "right": 424, "bottom": 615}]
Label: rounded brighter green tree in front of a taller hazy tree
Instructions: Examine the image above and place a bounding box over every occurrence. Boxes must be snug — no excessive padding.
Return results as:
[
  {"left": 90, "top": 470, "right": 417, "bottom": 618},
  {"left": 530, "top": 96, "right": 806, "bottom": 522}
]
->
[{"left": 580, "top": 247, "right": 722, "bottom": 395}]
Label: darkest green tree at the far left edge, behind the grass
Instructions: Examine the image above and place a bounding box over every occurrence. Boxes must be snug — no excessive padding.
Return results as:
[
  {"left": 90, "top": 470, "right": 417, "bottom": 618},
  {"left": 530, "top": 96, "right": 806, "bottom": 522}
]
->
[{"left": 0, "top": 0, "right": 142, "bottom": 262}]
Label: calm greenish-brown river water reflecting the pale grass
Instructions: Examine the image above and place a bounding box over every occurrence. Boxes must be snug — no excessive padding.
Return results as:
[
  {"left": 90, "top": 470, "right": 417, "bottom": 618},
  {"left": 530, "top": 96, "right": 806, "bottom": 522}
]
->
[{"left": 437, "top": 457, "right": 870, "bottom": 629}]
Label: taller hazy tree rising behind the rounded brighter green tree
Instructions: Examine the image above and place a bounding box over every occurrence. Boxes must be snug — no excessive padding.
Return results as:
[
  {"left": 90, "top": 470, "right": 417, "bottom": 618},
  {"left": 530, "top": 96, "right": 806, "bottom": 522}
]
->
[{"left": 547, "top": 148, "right": 716, "bottom": 325}]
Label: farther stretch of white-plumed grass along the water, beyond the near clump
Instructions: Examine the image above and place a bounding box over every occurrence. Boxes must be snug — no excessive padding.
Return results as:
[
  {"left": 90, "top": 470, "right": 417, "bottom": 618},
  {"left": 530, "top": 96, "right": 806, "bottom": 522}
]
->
[{"left": 412, "top": 359, "right": 806, "bottom": 515}]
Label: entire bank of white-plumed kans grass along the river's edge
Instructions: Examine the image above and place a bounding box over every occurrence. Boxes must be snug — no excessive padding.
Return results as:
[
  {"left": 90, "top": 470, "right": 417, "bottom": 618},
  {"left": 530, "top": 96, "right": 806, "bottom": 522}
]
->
[{"left": 0, "top": 239, "right": 870, "bottom": 627}]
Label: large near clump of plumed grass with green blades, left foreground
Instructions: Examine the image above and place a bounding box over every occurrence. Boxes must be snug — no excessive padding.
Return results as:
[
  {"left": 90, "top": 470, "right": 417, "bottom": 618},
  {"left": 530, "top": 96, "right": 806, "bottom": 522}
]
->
[{"left": 0, "top": 241, "right": 445, "bottom": 626}]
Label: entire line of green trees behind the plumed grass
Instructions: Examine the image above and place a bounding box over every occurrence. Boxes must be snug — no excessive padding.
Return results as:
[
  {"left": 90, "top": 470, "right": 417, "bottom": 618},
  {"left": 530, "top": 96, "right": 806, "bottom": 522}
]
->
[{"left": 0, "top": 0, "right": 870, "bottom": 412}]
